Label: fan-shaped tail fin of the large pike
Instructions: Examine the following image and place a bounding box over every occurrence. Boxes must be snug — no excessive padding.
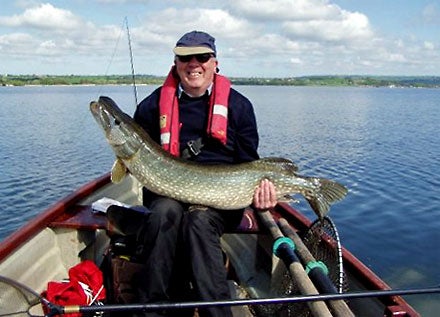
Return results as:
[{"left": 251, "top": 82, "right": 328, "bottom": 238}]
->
[{"left": 306, "top": 178, "right": 347, "bottom": 219}]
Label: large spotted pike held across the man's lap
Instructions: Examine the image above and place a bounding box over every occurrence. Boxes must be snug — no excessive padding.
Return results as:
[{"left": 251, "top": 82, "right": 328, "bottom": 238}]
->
[{"left": 90, "top": 97, "right": 347, "bottom": 218}]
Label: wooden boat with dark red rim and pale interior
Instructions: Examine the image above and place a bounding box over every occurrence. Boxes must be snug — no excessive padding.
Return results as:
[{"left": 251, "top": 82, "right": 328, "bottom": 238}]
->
[{"left": 0, "top": 175, "right": 419, "bottom": 316}]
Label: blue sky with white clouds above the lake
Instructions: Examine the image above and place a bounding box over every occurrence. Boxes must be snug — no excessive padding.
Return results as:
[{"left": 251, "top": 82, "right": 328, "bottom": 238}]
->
[{"left": 0, "top": 0, "right": 440, "bottom": 77}]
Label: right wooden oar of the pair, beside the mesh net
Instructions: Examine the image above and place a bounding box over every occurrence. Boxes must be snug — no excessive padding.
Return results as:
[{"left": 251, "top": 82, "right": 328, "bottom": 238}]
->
[{"left": 278, "top": 218, "right": 354, "bottom": 317}]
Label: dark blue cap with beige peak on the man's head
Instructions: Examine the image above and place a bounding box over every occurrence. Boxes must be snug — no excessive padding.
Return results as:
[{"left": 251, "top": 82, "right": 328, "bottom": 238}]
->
[{"left": 173, "top": 31, "right": 217, "bottom": 56}]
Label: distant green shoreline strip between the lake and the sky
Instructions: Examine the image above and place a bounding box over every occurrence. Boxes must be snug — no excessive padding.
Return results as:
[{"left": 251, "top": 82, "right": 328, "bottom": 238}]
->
[{"left": 0, "top": 74, "right": 440, "bottom": 88}]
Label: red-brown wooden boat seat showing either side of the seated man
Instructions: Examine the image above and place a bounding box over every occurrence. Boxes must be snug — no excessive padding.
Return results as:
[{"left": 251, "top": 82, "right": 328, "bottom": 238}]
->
[{"left": 49, "top": 205, "right": 260, "bottom": 233}]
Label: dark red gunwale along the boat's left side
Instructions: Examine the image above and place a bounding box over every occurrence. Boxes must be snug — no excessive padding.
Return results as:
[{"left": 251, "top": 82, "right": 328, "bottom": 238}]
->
[{"left": 0, "top": 174, "right": 110, "bottom": 262}]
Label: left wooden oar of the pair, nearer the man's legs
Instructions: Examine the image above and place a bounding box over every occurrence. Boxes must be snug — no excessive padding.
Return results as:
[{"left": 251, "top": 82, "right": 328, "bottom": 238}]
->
[{"left": 257, "top": 210, "right": 332, "bottom": 317}]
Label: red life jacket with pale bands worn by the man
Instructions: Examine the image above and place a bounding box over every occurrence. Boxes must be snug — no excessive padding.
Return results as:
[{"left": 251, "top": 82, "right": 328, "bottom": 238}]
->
[{"left": 159, "top": 66, "right": 231, "bottom": 156}]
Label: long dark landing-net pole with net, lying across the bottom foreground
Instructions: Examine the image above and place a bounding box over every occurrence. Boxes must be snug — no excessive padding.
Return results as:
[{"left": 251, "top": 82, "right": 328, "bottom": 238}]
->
[{"left": 0, "top": 276, "right": 440, "bottom": 317}]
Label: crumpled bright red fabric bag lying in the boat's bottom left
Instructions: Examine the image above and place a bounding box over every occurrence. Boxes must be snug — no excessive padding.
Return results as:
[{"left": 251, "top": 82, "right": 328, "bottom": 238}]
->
[{"left": 43, "top": 260, "right": 106, "bottom": 317}]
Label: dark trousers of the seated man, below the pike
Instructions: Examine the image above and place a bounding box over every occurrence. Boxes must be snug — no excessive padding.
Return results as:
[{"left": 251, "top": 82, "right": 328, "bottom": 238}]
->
[{"left": 138, "top": 197, "right": 243, "bottom": 317}]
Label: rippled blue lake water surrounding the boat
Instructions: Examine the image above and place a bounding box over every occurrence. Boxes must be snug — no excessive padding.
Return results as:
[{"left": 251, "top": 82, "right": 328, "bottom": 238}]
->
[{"left": 0, "top": 86, "right": 440, "bottom": 316}]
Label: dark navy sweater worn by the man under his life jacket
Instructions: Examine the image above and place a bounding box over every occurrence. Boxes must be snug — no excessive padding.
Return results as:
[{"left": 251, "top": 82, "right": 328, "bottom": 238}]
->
[{"left": 134, "top": 87, "right": 259, "bottom": 164}]
